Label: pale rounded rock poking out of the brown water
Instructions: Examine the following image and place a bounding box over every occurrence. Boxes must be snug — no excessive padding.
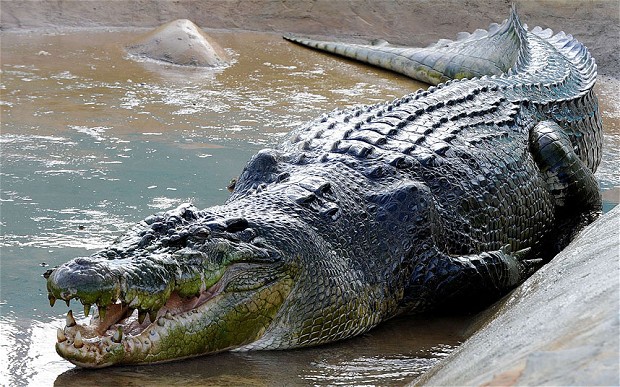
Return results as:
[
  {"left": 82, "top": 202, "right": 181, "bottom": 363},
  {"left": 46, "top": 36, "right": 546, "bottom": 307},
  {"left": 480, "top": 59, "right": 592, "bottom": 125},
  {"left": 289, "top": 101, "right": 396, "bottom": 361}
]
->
[{"left": 126, "top": 19, "right": 230, "bottom": 67}]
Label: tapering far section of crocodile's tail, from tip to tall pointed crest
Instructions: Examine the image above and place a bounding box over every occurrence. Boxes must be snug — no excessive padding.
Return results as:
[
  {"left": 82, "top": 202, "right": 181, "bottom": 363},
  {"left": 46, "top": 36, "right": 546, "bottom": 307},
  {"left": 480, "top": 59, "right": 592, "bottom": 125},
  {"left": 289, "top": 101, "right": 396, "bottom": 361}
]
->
[{"left": 284, "top": 7, "right": 529, "bottom": 85}]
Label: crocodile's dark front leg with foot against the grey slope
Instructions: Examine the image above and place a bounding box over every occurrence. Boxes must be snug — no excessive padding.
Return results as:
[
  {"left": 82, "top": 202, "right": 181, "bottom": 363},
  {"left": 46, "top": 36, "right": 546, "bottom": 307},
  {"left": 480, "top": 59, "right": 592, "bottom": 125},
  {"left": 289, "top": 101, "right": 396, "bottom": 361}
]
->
[{"left": 392, "top": 183, "right": 542, "bottom": 313}]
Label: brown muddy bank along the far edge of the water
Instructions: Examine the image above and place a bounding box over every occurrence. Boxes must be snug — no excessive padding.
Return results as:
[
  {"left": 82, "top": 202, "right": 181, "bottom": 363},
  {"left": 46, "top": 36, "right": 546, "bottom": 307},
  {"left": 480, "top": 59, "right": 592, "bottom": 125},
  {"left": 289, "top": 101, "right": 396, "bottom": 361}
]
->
[{"left": 0, "top": 0, "right": 620, "bottom": 76}]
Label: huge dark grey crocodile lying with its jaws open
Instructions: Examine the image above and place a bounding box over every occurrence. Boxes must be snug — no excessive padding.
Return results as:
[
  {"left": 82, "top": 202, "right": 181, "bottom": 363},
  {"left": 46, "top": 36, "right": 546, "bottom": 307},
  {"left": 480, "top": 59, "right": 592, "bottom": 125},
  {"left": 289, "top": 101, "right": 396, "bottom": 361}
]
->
[{"left": 45, "top": 8, "right": 602, "bottom": 368}]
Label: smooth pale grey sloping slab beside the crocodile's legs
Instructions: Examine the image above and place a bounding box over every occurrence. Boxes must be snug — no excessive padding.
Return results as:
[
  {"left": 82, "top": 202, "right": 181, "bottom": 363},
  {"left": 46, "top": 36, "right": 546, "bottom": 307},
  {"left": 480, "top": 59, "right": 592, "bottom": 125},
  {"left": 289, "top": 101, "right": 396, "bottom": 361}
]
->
[{"left": 414, "top": 206, "right": 620, "bottom": 386}]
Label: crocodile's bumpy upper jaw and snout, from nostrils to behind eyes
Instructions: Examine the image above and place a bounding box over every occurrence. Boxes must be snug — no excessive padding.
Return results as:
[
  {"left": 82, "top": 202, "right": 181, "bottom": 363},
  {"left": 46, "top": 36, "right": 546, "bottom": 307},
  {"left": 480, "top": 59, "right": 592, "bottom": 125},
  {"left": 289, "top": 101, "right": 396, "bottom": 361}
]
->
[{"left": 45, "top": 205, "right": 272, "bottom": 328}]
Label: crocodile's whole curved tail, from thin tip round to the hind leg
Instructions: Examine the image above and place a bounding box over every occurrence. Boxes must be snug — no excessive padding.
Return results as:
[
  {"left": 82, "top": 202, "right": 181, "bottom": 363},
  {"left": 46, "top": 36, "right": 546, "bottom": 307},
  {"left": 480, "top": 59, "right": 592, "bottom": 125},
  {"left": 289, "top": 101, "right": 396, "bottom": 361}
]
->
[{"left": 286, "top": 7, "right": 602, "bottom": 171}]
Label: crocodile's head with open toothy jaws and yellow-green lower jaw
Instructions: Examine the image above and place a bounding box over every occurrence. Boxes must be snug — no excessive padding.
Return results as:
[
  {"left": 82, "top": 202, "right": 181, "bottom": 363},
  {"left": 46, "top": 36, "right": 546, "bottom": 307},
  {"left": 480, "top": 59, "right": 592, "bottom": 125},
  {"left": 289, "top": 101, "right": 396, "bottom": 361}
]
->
[{"left": 46, "top": 205, "right": 296, "bottom": 368}]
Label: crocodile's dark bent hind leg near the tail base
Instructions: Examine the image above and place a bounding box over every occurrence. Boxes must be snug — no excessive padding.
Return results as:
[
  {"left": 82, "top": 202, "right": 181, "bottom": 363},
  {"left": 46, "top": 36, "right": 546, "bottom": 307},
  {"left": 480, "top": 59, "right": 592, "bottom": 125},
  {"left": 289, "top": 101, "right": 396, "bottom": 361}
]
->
[{"left": 529, "top": 121, "right": 602, "bottom": 251}]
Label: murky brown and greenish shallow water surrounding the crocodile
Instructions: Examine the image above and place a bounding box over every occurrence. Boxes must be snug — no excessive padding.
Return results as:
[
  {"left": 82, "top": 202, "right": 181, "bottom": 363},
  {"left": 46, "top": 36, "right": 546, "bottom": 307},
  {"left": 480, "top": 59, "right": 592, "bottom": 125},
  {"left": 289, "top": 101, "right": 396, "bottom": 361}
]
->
[{"left": 0, "top": 31, "right": 620, "bottom": 385}]
